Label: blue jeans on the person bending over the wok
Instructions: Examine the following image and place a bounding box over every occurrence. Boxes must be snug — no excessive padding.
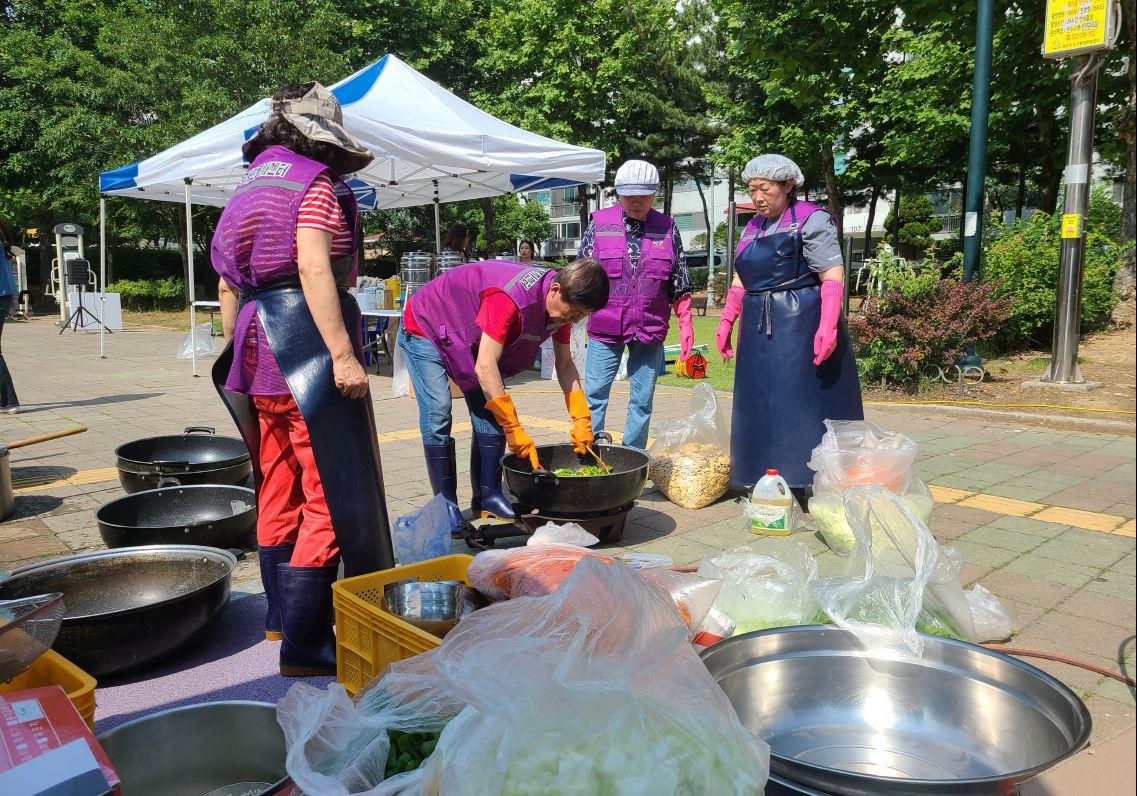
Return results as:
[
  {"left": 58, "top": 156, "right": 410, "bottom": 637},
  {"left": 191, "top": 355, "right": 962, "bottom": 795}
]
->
[{"left": 398, "top": 329, "right": 505, "bottom": 445}]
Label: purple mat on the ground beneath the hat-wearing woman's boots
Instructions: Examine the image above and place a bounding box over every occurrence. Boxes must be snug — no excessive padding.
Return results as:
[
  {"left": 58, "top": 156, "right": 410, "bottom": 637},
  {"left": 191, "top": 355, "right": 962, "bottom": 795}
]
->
[{"left": 94, "top": 595, "right": 335, "bottom": 733}]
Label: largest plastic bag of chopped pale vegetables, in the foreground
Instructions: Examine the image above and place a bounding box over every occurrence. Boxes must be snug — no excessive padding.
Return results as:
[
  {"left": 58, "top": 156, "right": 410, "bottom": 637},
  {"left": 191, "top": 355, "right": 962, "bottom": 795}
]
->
[{"left": 413, "top": 557, "right": 769, "bottom": 796}]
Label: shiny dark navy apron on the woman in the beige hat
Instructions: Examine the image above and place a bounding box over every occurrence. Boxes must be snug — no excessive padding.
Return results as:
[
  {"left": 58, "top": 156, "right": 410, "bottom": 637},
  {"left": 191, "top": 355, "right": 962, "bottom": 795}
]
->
[{"left": 213, "top": 282, "right": 395, "bottom": 578}]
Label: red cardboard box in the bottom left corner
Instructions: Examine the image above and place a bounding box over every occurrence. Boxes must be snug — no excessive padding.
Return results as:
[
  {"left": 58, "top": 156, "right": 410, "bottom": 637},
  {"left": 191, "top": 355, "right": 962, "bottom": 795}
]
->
[{"left": 0, "top": 686, "right": 119, "bottom": 796}]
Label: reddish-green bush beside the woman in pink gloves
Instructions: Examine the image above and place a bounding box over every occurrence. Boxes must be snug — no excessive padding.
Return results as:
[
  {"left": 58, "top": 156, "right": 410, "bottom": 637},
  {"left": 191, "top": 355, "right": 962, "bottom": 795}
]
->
[{"left": 849, "top": 278, "right": 1013, "bottom": 384}]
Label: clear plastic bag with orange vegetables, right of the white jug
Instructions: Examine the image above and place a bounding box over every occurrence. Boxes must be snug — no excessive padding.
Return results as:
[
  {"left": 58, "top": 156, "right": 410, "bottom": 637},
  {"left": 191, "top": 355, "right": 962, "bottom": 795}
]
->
[{"left": 808, "top": 420, "right": 935, "bottom": 556}]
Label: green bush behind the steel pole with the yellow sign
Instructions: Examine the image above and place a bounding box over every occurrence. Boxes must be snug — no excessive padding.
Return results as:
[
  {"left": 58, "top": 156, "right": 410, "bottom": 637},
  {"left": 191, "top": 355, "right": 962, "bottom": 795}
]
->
[{"left": 984, "top": 191, "right": 1120, "bottom": 350}]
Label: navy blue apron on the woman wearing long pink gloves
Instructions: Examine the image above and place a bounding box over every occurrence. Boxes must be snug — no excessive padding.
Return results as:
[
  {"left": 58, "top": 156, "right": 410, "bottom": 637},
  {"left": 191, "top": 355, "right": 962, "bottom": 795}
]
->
[{"left": 730, "top": 205, "right": 864, "bottom": 490}]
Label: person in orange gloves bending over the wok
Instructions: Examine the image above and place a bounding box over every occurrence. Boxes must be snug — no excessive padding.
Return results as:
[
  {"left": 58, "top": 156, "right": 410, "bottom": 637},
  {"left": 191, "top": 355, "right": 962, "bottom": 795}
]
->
[{"left": 398, "top": 259, "right": 608, "bottom": 532}]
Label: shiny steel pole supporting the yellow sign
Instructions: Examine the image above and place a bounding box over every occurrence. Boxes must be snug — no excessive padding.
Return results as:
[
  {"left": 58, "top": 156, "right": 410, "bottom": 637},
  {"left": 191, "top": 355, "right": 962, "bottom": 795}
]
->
[{"left": 1040, "top": 56, "right": 1097, "bottom": 384}]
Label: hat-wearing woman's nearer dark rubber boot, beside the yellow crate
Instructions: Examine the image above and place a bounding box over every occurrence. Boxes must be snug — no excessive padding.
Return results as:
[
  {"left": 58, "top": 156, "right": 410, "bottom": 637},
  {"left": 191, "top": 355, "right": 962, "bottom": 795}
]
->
[{"left": 276, "top": 564, "right": 339, "bottom": 677}]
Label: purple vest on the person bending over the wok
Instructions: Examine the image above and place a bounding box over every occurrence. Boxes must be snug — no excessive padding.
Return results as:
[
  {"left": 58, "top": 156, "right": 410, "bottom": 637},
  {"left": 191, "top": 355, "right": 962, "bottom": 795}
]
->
[{"left": 410, "top": 260, "right": 556, "bottom": 392}]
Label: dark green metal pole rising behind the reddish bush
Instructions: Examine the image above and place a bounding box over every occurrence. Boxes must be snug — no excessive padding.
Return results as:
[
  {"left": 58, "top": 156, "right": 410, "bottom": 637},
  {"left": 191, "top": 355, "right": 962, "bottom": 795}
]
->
[{"left": 959, "top": 0, "right": 995, "bottom": 367}]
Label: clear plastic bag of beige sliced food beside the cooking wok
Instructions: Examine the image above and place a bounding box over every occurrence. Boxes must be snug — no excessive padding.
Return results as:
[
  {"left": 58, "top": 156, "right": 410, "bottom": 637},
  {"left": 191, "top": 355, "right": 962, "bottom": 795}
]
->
[{"left": 648, "top": 384, "right": 730, "bottom": 508}]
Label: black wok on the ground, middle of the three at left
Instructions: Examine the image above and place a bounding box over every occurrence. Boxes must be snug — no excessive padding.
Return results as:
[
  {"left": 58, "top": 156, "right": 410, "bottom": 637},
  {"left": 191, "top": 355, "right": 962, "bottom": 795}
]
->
[{"left": 94, "top": 484, "right": 257, "bottom": 549}]
